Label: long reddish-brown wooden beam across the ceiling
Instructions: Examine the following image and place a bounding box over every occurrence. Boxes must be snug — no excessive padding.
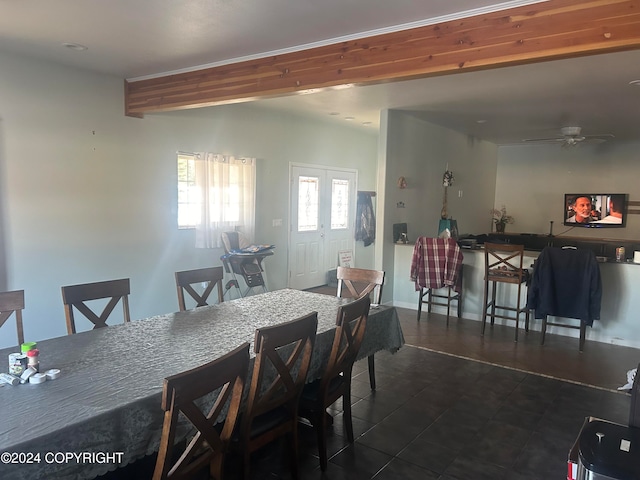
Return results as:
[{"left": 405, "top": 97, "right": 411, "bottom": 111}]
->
[{"left": 125, "top": 0, "right": 640, "bottom": 117}]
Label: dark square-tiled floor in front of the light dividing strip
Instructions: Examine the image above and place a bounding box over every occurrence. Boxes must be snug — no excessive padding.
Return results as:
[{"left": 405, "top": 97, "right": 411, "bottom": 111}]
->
[{"left": 239, "top": 346, "right": 629, "bottom": 480}]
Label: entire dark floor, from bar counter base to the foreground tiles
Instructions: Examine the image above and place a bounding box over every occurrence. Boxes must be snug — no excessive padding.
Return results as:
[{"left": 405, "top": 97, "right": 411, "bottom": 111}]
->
[{"left": 102, "top": 302, "right": 640, "bottom": 480}]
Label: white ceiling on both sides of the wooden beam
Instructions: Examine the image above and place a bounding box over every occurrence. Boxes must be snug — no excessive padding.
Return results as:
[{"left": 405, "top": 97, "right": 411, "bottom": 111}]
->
[{"left": 0, "top": 0, "right": 640, "bottom": 144}]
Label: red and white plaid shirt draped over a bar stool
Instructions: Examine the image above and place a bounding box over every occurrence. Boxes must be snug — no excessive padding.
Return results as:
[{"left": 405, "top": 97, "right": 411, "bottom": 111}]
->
[{"left": 411, "top": 237, "right": 463, "bottom": 293}]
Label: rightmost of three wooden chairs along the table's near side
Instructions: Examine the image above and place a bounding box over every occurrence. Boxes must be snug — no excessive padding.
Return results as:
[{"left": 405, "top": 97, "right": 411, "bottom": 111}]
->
[{"left": 300, "top": 295, "right": 371, "bottom": 471}]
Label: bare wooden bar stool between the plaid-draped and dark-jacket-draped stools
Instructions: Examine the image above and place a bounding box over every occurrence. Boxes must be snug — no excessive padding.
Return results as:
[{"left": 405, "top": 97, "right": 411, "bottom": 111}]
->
[{"left": 481, "top": 243, "right": 529, "bottom": 342}]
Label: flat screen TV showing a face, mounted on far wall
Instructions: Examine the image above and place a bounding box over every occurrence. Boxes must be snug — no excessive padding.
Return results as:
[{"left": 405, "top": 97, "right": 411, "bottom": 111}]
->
[{"left": 563, "top": 193, "right": 628, "bottom": 228}]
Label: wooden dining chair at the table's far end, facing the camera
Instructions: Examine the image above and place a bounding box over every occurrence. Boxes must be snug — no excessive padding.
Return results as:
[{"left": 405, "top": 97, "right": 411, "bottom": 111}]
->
[{"left": 336, "top": 267, "right": 384, "bottom": 390}]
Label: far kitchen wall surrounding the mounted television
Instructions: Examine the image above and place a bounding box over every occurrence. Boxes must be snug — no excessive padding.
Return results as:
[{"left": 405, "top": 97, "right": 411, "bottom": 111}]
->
[{"left": 496, "top": 141, "right": 640, "bottom": 242}]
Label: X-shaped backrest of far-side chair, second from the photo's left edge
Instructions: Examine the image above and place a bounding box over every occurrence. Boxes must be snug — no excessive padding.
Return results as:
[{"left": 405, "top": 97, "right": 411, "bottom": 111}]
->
[{"left": 62, "top": 278, "right": 130, "bottom": 335}]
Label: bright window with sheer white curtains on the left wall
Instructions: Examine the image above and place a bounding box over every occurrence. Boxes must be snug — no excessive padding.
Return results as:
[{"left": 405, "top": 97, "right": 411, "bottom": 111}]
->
[{"left": 178, "top": 153, "right": 256, "bottom": 248}]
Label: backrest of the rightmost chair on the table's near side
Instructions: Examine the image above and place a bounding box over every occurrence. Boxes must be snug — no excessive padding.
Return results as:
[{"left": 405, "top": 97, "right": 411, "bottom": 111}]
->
[{"left": 320, "top": 295, "right": 371, "bottom": 392}]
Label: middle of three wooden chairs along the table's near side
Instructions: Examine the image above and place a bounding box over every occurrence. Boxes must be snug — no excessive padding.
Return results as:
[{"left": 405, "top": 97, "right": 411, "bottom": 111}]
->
[{"left": 237, "top": 312, "right": 318, "bottom": 480}]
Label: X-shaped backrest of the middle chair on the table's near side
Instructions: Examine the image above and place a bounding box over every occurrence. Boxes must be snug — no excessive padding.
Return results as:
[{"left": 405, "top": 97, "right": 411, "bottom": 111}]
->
[{"left": 241, "top": 312, "right": 318, "bottom": 439}]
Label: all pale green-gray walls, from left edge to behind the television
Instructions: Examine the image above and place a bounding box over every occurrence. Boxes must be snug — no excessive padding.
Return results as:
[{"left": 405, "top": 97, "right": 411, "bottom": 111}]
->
[{"left": 0, "top": 49, "right": 640, "bottom": 348}]
